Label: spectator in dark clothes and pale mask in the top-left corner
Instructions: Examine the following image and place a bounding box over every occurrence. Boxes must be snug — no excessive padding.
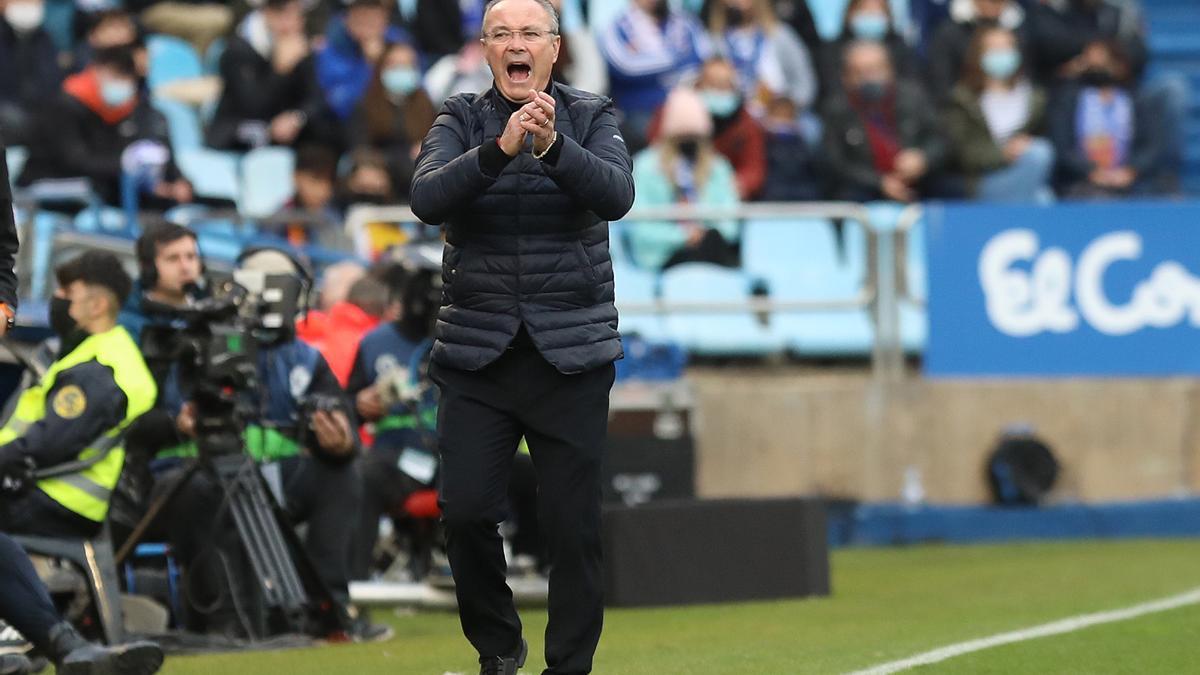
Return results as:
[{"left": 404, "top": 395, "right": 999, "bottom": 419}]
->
[{"left": 0, "top": 0, "right": 62, "bottom": 145}]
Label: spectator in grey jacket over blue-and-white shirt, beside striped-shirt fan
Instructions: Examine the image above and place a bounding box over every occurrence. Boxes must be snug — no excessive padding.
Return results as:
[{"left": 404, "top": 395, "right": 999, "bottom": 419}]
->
[{"left": 708, "top": 0, "right": 817, "bottom": 109}]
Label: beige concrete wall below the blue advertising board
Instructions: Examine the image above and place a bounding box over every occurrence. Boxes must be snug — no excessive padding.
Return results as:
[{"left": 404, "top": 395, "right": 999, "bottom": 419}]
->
[{"left": 689, "top": 368, "right": 1200, "bottom": 503}]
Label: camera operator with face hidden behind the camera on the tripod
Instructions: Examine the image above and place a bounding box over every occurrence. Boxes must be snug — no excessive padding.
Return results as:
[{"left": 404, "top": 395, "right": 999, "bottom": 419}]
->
[{"left": 146, "top": 249, "right": 390, "bottom": 640}]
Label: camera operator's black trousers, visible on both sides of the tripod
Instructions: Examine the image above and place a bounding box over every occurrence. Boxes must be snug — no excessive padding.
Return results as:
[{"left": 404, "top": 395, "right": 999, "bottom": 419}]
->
[{"left": 156, "top": 455, "right": 362, "bottom": 635}]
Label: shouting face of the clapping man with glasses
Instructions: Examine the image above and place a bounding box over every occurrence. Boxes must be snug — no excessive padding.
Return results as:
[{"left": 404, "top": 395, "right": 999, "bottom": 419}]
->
[{"left": 484, "top": 0, "right": 560, "bottom": 102}]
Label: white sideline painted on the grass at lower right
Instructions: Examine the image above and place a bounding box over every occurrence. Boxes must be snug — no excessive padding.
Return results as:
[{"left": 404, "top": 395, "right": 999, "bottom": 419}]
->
[{"left": 850, "top": 589, "right": 1200, "bottom": 675}]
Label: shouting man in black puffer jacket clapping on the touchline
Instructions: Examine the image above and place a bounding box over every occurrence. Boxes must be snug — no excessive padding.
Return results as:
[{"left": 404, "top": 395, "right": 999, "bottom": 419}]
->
[{"left": 412, "top": 0, "right": 634, "bottom": 674}]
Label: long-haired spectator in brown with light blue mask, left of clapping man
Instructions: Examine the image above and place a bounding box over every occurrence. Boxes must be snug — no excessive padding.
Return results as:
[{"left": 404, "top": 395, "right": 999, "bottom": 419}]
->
[{"left": 347, "top": 43, "right": 434, "bottom": 203}]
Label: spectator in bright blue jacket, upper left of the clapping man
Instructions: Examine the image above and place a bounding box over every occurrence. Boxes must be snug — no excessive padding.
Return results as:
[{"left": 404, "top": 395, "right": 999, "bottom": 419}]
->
[{"left": 317, "top": 0, "right": 404, "bottom": 123}]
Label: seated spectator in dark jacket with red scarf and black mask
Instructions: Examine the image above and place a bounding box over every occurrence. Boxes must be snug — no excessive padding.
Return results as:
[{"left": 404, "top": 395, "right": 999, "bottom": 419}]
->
[{"left": 822, "top": 41, "right": 949, "bottom": 202}]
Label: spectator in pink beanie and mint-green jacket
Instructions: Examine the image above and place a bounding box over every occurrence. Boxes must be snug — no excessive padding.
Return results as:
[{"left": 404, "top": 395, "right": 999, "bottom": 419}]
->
[{"left": 629, "top": 88, "right": 740, "bottom": 269}]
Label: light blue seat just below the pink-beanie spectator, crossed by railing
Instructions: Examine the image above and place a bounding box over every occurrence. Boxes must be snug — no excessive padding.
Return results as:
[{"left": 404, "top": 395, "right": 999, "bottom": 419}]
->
[{"left": 661, "top": 263, "right": 785, "bottom": 357}]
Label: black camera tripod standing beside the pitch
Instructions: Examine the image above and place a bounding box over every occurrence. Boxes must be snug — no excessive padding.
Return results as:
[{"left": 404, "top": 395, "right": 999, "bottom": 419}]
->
[{"left": 115, "top": 444, "right": 346, "bottom": 638}]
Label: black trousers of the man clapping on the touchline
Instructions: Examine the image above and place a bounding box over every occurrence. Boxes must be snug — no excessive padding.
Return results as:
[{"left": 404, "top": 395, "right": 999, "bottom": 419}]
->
[{"left": 431, "top": 347, "right": 616, "bottom": 675}]
